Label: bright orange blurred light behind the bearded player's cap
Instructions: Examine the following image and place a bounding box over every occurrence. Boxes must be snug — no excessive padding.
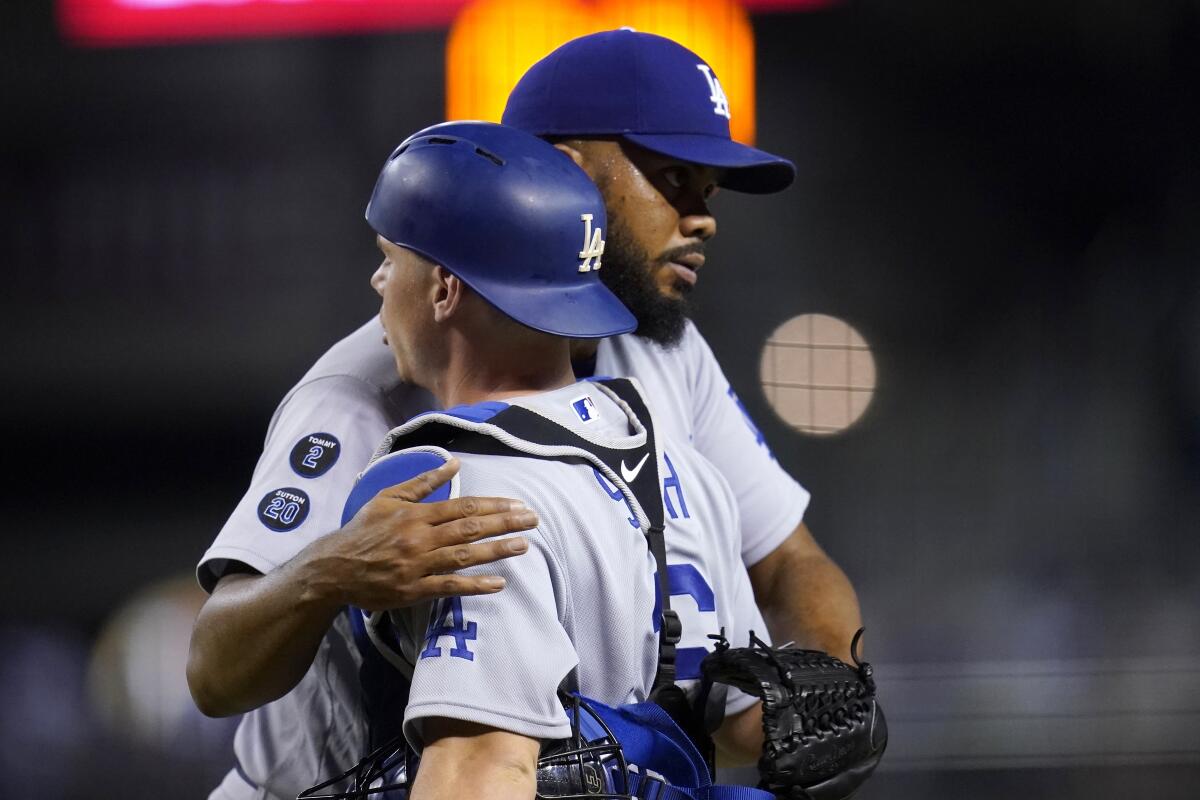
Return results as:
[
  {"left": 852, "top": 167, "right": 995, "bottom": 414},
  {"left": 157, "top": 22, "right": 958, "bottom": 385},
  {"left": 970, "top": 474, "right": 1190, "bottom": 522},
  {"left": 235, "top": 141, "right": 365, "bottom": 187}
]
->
[{"left": 446, "top": 0, "right": 755, "bottom": 144}]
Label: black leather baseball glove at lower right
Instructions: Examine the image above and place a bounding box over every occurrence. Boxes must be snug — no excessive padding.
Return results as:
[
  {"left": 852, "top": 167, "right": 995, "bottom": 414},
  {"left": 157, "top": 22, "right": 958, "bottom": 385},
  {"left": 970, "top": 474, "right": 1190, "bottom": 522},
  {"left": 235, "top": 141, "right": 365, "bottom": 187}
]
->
[{"left": 701, "top": 630, "right": 888, "bottom": 800}]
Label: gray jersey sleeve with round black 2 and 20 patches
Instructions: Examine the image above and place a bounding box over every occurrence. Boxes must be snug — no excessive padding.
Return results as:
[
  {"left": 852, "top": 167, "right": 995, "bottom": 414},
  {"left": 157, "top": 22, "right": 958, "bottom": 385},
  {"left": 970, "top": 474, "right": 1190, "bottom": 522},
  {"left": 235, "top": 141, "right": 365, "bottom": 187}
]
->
[{"left": 197, "top": 375, "right": 391, "bottom": 591}]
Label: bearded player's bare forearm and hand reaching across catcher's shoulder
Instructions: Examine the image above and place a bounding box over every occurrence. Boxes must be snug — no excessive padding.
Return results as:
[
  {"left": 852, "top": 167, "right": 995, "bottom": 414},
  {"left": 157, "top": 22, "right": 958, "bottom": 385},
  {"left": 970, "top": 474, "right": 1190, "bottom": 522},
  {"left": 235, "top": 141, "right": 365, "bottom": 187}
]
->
[{"left": 187, "top": 459, "right": 538, "bottom": 716}]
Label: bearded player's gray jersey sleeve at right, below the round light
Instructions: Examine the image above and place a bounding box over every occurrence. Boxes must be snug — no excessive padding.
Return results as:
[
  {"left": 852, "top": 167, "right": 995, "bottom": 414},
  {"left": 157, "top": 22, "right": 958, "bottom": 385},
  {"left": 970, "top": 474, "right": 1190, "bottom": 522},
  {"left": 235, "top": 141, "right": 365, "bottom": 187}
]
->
[{"left": 680, "top": 325, "right": 810, "bottom": 566}]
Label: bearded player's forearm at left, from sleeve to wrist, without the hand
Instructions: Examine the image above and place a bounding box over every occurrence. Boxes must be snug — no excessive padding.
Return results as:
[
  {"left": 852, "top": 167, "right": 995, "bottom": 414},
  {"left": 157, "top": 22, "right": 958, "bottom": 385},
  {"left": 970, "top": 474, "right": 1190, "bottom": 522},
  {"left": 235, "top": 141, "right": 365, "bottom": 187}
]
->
[{"left": 187, "top": 542, "right": 342, "bottom": 716}]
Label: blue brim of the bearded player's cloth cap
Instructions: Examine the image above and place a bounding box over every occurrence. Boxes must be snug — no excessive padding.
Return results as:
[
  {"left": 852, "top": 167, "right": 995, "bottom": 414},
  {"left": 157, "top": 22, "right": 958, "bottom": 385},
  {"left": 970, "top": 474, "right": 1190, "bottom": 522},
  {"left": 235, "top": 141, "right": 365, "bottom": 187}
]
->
[{"left": 622, "top": 133, "right": 796, "bottom": 194}]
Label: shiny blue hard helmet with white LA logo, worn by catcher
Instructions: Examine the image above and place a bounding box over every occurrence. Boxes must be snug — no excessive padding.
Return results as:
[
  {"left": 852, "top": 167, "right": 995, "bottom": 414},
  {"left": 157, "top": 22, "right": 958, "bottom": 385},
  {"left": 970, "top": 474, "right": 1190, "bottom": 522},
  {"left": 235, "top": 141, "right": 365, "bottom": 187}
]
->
[{"left": 366, "top": 122, "right": 637, "bottom": 338}]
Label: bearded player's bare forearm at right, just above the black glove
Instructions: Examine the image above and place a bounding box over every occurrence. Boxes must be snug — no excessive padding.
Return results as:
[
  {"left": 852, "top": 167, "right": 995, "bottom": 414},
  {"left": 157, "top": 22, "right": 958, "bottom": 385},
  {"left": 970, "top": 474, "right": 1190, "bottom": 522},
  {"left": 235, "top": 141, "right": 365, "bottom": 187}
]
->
[{"left": 750, "top": 523, "right": 863, "bottom": 663}]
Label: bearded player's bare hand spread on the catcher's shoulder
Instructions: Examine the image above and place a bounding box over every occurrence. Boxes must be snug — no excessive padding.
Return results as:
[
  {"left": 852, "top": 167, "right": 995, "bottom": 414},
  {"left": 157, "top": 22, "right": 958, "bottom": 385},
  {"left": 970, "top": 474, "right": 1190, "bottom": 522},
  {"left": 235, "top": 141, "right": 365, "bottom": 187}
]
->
[{"left": 305, "top": 458, "right": 538, "bottom": 610}]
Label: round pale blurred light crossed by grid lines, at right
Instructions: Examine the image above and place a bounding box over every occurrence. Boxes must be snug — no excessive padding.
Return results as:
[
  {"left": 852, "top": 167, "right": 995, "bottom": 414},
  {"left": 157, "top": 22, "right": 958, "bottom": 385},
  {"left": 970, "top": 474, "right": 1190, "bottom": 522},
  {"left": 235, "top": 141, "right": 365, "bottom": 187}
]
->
[{"left": 758, "top": 314, "right": 875, "bottom": 435}]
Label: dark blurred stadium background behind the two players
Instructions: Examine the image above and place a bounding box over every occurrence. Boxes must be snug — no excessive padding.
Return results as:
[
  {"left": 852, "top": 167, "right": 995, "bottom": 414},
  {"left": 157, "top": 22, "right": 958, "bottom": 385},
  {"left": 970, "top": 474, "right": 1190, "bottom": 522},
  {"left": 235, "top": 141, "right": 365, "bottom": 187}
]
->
[{"left": 0, "top": 0, "right": 1200, "bottom": 799}]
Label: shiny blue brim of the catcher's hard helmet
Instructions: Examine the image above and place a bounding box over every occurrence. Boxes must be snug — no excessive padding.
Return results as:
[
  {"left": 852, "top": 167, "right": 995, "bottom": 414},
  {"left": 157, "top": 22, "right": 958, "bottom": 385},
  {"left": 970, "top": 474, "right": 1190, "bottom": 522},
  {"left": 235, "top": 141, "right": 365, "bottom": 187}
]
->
[{"left": 451, "top": 269, "right": 637, "bottom": 339}]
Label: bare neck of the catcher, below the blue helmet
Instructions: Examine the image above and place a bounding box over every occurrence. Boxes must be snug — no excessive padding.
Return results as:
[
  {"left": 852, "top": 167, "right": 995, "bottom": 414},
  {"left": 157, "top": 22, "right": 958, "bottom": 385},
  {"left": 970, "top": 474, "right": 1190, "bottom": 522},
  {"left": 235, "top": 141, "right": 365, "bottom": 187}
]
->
[{"left": 430, "top": 338, "right": 575, "bottom": 408}]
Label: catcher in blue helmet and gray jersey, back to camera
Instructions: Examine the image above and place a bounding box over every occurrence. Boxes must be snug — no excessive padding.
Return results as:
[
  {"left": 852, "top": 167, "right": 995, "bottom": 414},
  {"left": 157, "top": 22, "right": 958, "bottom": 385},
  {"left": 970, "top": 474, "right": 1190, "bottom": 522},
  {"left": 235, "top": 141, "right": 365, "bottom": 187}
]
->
[{"left": 293, "top": 122, "right": 772, "bottom": 800}]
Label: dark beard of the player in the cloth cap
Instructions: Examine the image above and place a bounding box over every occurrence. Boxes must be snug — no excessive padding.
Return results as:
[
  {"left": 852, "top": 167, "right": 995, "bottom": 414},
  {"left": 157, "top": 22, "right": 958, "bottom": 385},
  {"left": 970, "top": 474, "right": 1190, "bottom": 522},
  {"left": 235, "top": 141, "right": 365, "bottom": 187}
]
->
[{"left": 600, "top": 213, "right": 694, "bottom": 348}]
